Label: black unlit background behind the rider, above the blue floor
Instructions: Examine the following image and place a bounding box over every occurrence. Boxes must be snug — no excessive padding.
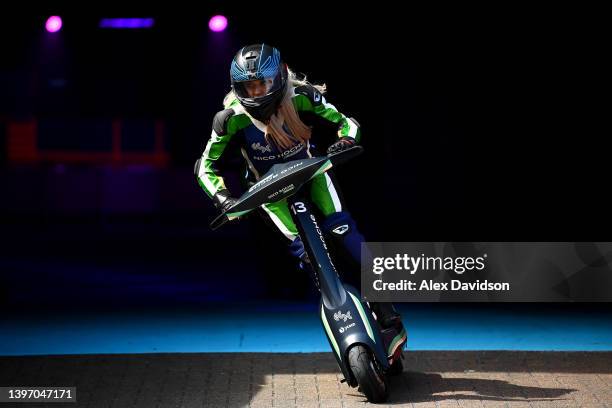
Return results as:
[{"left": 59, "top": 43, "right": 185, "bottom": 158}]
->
[{"left": 0, "top": 2, "right": 612, "bottom": 309}]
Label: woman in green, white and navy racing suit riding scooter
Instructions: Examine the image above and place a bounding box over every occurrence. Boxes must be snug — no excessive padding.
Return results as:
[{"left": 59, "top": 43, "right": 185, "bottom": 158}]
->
[{"left": 196, "top": 44, "right": 401, "bottom": 328}]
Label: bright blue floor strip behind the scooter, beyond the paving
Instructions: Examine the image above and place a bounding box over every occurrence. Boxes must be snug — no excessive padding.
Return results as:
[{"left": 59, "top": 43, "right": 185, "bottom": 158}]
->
[{"left": 0, "top": 303, "right": 612, "bottom": 355}]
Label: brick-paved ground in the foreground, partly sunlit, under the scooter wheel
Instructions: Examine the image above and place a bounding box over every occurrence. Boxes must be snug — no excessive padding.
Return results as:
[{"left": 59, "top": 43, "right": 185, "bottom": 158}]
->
[{"left": 0, "top": 351, "right": 612, "bottom": 408}]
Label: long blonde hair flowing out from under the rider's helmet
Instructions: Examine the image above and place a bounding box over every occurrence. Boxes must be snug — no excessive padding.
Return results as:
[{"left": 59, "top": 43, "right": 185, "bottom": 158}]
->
[{"left": 223, "top": 68, "right": 327, "bottom": 151}]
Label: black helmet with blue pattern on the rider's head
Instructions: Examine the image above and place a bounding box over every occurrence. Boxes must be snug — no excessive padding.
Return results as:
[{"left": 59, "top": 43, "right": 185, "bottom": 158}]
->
[{"left": 230, "top": 44, "right": 287, "bottom": 121}]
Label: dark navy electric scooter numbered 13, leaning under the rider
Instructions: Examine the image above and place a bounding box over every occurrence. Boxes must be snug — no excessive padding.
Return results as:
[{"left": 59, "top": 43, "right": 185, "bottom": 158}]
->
[{"left": 210, "top": 146, "right": 406, "bottom": 402}]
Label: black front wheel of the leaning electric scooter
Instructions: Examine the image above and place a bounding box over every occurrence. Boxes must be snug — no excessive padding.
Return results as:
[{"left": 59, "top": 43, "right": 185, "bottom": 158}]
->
[{"left": 348, "top": 344, "right": 388, "bottom": 402}]
